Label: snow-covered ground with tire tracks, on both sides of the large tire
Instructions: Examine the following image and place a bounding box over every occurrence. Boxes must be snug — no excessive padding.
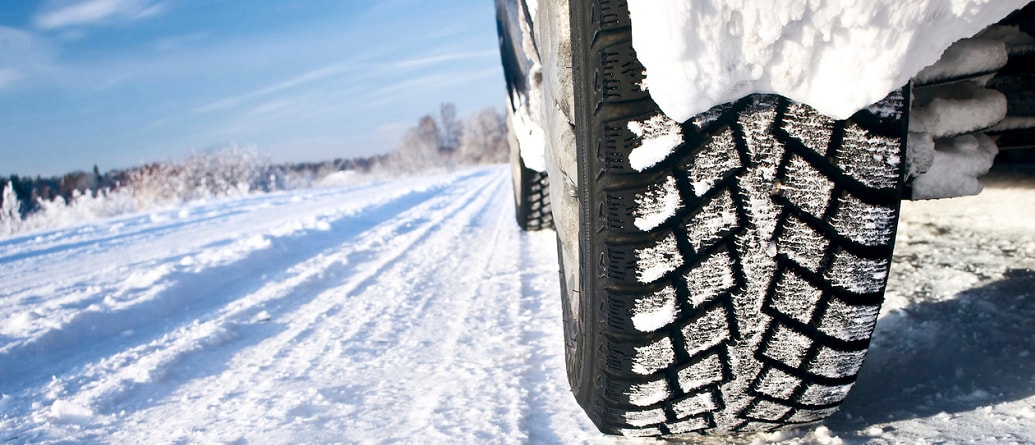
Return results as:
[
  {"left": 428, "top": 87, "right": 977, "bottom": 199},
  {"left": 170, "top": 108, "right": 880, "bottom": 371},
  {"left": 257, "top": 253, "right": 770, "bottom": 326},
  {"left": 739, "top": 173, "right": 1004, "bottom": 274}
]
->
[{"left": 0, "top": 167, "right": 1035, "bottom": 444}]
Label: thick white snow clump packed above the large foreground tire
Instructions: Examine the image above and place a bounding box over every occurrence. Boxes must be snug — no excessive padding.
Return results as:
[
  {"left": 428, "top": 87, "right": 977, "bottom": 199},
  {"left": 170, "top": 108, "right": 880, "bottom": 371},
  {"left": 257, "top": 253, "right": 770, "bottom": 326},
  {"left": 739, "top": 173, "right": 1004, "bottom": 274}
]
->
[{"left": 629, "top": 0, "right": 1028, "bottom": 122}]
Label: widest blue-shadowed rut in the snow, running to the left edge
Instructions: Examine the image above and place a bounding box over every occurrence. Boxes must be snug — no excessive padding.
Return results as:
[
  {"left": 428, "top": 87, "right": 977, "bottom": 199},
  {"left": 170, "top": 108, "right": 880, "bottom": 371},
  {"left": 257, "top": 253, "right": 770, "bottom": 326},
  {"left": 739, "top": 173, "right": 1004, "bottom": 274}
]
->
[{"left": 0, "top": 171, "right": 488, "bottom": 393}]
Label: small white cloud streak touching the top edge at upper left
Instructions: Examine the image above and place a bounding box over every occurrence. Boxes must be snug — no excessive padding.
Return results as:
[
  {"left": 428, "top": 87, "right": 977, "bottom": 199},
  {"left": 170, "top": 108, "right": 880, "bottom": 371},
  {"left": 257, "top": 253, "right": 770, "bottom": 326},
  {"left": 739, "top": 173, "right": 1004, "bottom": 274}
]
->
[{"left": 33, "top": 0, "right": 165, "bottom": 31}]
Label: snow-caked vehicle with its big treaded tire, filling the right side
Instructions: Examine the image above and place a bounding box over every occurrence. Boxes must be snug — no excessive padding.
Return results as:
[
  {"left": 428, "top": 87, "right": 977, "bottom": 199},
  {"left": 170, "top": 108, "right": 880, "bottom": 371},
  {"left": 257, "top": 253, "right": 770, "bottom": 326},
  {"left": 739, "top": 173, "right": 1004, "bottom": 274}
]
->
[{"left": 497, "top": 0, "right": 1035, "bottom": 436}]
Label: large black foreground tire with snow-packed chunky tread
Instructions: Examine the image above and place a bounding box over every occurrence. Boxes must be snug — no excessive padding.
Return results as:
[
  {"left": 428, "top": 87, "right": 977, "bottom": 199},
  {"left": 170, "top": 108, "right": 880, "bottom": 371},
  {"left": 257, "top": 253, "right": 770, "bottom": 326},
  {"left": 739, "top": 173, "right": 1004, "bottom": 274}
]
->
[{"left": 562, "top": 0, "right": 908, "bottom": 436}]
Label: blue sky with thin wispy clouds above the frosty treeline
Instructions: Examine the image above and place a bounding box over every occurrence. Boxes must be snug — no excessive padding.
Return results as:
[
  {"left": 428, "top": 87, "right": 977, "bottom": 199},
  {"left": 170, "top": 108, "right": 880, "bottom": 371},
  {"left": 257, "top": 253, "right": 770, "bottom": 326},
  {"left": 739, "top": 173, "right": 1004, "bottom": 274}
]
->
[{"left": 0, "top": 0, "right": 505, "bottom": 176}]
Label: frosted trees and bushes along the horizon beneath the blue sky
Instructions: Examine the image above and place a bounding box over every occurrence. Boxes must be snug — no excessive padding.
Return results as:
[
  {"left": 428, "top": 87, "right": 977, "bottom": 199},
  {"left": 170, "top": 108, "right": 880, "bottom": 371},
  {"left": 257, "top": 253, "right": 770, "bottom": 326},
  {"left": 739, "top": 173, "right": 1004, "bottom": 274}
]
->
[{"left": 0, "top": 103, "right": 508, "bottom": 220}]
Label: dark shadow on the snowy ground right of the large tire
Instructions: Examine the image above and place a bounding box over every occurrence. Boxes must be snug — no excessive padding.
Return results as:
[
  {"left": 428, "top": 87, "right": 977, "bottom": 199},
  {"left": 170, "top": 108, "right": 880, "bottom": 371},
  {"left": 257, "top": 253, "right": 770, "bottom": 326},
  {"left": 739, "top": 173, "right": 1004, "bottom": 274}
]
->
[{"left": 825, "top": 269, "right": 1035, "bottom": 434}]
